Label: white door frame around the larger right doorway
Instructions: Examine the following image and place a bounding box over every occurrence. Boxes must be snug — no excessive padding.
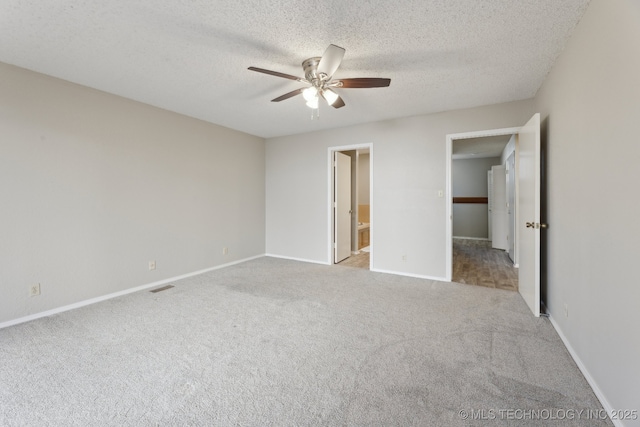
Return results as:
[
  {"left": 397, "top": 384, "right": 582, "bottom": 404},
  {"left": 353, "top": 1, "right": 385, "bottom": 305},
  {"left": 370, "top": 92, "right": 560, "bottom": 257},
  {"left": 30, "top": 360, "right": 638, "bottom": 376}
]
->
[{"left": 445, "top": 126, "right": 522, "bottom": 282}]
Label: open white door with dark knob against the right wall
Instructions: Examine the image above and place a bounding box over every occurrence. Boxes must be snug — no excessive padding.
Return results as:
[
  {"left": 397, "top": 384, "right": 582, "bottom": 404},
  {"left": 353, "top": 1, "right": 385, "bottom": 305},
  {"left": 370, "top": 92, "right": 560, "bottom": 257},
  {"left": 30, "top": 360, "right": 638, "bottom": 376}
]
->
[{"left": 517, "top": 113, "right": 541, "bottom": 317}]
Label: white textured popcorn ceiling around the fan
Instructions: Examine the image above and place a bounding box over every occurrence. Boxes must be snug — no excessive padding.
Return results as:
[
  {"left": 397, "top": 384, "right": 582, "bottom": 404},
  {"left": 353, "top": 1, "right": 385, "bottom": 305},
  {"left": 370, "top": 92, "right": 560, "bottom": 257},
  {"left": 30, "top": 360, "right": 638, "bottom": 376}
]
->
[{"left": 0, "top": 0, "right": 589, "bottom": 137}]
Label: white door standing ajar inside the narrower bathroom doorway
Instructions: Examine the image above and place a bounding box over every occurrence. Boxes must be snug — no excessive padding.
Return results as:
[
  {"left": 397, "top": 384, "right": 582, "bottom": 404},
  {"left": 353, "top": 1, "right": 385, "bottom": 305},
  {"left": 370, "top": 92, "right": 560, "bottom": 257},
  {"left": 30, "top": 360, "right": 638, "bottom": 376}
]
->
[{"left": 333, "top": 152, "right": 351, "bottom": 264}]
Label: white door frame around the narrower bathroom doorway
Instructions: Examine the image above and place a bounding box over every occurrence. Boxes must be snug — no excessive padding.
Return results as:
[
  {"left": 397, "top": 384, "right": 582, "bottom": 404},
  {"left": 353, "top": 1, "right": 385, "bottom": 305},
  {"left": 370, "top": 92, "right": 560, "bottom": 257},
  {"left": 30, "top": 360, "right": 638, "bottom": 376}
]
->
[{"left": 326, "top": 142, "right": 375, "bottom": 270}]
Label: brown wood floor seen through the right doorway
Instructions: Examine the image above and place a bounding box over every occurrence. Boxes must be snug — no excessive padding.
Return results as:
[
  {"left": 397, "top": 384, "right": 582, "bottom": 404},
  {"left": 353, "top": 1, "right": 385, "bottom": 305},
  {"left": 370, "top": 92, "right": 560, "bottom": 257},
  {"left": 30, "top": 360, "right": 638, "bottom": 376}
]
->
[{"left": 452, "top": 239, "right": 518, "bottom": 291}]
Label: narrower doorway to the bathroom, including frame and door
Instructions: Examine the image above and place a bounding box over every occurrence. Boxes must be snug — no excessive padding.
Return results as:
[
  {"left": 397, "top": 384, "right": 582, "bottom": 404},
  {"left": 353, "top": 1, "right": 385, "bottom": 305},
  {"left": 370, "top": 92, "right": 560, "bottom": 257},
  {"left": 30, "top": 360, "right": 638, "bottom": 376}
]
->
[{"left": 327, "top": 144, "right": 374, "bottom": 269}]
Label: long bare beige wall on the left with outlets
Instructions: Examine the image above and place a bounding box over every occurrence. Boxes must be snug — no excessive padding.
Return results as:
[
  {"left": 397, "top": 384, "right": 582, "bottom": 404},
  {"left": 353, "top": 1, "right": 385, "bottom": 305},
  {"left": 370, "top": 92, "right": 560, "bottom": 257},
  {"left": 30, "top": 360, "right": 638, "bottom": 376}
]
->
[{"left": 0, "top": 64, "right": 265, "bottom": 323}]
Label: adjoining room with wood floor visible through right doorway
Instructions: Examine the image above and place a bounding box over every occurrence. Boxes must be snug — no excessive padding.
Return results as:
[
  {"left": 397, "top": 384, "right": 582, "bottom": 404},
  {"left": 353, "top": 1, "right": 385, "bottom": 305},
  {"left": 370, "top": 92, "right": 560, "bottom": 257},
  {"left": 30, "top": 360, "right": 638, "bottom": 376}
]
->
[{"left": 451, "top": 134, "right": 518, "bottom": 291}]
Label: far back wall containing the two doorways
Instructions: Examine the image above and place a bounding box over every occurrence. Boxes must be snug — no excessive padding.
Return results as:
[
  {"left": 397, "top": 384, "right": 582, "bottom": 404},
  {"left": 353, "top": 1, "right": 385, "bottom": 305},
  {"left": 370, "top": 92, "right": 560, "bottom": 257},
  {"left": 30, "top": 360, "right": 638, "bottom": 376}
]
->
[{"left": 266, "top": 100, "right": 534, "bottom": 278}]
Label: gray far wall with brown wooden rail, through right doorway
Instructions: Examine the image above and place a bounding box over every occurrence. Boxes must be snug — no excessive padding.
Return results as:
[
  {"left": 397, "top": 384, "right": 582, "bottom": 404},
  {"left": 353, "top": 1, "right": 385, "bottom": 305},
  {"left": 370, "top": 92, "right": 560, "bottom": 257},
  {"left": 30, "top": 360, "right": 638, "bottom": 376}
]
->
[{"left": 451, "top": 157, "right": 500, "bottom": 239}]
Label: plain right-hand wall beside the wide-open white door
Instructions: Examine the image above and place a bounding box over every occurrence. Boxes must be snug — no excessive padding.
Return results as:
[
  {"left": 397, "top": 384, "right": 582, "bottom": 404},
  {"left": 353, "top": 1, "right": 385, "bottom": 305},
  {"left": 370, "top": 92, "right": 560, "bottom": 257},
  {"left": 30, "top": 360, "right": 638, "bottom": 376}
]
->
[{"left": 535, "top": 0, "right": 640, "bottom": 426}]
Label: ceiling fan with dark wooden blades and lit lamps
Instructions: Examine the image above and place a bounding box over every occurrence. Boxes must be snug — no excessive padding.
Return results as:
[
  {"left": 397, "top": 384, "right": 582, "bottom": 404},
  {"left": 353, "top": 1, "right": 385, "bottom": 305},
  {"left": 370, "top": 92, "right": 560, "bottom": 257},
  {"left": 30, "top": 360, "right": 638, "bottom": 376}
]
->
[{"left": 249, "top": 44, "right": 391, "bottom": 109}]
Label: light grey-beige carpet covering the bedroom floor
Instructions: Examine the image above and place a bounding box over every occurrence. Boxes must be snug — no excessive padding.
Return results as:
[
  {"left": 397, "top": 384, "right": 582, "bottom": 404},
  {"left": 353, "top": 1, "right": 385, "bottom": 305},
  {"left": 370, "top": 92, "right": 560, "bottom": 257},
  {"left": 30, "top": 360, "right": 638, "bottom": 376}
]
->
[{"left": 0, "top": 257, "right": 611, "bottom": 426}]
